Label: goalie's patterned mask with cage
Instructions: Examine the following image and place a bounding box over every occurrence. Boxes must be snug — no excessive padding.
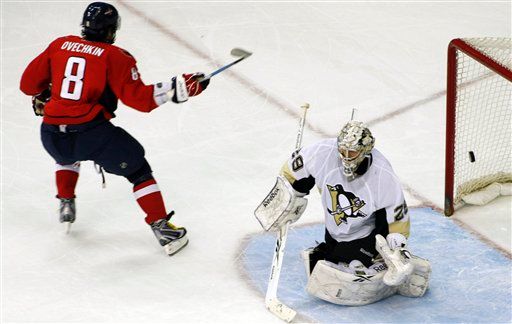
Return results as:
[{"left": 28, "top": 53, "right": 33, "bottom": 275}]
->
[{"left": 338, "top": 120, "right": 375, "bottom": 179}]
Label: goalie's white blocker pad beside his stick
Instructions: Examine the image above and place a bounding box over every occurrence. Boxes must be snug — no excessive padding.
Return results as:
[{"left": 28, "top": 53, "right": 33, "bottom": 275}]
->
[{"left": 254, "top": 176, "right": 308, "bottom": 231}]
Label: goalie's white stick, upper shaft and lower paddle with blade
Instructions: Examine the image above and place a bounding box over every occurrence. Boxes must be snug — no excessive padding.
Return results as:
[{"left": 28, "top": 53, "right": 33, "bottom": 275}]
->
[{"left": 265, "top": 103, "right": 309, "bottom": 322}]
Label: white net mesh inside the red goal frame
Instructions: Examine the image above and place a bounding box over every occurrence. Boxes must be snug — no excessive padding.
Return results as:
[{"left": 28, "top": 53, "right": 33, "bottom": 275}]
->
[{"left": 454, "top": 38, "right": 512, "bottom": 204}]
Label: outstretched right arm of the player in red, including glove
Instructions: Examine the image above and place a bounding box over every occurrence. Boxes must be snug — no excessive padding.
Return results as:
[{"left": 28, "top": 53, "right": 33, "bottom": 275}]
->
[{"left": 107, "top": 48, "right": 208, "bottom": 112}]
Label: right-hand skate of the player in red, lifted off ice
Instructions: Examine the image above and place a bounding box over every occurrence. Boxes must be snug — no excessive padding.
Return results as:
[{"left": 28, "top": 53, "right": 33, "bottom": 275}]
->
[{"left": 150, "top": 211, "right": 188, "bottom": 255}]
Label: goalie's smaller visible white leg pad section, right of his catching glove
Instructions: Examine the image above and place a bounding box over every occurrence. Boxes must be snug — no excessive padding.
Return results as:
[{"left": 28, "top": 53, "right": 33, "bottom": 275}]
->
[{"left": 398, "top": 255, "right": 432, "bottom": 297}]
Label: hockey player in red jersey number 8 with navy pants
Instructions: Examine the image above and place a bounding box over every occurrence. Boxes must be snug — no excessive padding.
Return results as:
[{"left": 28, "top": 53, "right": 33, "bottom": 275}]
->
[{"left": 20, "top": 2, "right": 209, "bottom": 255}]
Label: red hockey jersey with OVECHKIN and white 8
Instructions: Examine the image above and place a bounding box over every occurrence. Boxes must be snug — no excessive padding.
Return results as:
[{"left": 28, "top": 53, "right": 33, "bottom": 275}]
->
[{"left": 20, "top": 36, "right": 158, "bottom": 125}]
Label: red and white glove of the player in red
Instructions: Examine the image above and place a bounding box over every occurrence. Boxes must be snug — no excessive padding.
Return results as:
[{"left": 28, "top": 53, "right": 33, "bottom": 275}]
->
[{"left": 153, "top": 72, "right": 210, "bottom": 106}]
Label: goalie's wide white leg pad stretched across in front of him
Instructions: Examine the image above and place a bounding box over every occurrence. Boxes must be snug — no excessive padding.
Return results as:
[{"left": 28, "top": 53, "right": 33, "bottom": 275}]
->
[{"left": 307, "top": 260, "right": 398, "bottom": 306}]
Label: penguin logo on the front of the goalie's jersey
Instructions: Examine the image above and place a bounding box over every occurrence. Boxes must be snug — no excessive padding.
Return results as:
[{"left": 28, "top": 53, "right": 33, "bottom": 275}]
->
[{"left": 327, "top": 184, "right": 366, "bottom": 226}]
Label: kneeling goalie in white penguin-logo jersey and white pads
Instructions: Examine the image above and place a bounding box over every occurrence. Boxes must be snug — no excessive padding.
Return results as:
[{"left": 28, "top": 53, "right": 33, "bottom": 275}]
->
[{"left": 256, "top": 121, "right": 431, "bottom": 305}]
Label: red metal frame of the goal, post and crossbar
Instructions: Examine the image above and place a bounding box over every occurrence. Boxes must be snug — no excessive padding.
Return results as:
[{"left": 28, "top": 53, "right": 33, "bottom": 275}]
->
[{"left": 444, "top": 38, "right": 512, "bottom": 216}]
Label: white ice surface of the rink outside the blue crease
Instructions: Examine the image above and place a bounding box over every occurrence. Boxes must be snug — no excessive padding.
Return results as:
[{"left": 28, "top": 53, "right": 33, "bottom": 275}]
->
[{"left": 0, "top": 0, "right": 512, "bottom": 323}]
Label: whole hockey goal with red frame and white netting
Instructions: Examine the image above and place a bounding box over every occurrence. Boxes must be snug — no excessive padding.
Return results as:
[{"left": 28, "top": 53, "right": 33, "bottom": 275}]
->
[{"left": 444, "top": 38, "right": 512, "bottom": 216}]
